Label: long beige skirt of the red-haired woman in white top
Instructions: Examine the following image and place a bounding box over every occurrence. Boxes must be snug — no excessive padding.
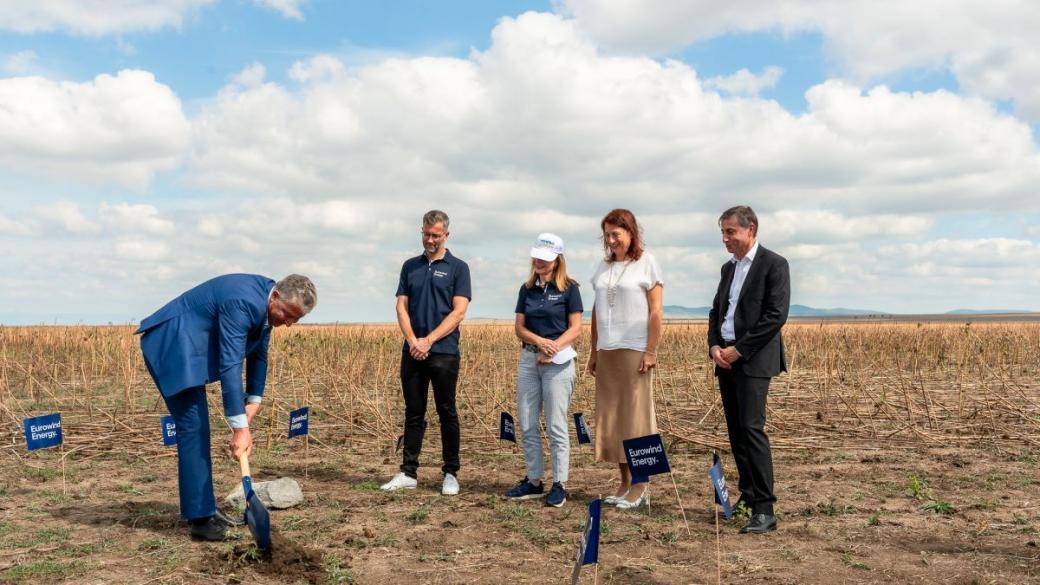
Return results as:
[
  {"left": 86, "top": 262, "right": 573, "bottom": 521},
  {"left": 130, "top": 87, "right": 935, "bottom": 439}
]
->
[{"left": 595, "top": 350, "right": 657, "bottom": 463}]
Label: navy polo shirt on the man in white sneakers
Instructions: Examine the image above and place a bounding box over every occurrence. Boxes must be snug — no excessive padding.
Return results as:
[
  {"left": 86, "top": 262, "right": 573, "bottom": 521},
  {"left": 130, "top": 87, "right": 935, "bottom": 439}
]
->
[{"left": 397, "top": 250, "right": 473, "bottom": 355}]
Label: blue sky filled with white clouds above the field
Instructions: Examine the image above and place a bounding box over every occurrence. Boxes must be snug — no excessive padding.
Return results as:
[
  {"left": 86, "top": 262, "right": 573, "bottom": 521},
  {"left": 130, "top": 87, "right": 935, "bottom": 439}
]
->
[{"left": 0, "top": 0, "right": 1040, "bottom": 324}]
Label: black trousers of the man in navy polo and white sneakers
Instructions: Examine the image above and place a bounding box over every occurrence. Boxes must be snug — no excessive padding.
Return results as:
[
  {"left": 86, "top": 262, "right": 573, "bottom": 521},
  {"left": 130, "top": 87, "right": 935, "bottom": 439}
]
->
[{"left": 400, "top": 351, "right": 459, "bottom": 478}]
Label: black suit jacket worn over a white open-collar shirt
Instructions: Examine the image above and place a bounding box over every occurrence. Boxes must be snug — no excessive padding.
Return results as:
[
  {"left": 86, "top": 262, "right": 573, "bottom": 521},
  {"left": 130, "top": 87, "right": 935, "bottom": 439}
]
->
[{"left": 708, "top": 245, "right": 790, "bottom": 378}]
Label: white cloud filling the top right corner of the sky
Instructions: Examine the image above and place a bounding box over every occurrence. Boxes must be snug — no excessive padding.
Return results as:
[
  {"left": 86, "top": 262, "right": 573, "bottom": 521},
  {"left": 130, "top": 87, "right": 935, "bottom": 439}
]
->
[{"left": 558, "top": 0, "right": 1040, "bottom": 121}]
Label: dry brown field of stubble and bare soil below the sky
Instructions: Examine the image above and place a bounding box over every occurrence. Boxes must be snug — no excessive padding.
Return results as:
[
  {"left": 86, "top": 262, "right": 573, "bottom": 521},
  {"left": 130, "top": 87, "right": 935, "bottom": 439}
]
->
[{"left": 0, "top": 323, "right": 1040, "bottom": 584}]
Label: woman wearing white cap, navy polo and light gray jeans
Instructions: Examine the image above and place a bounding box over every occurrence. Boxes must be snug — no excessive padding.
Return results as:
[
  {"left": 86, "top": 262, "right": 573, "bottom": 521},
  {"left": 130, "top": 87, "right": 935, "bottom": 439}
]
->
[{"left": 505, "top": 233, "right": 583, "bottom": 508}]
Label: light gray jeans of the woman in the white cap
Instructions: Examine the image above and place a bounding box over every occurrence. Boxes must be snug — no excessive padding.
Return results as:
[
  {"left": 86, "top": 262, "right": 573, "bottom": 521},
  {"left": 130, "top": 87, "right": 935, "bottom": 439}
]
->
[{"left": 517, "top": 350, "right": 575, "bottom": 483}]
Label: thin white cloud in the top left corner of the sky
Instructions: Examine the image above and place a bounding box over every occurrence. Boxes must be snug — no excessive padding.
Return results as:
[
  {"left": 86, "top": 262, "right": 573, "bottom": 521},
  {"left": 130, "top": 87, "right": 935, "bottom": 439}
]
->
[{"left": 0, "top": 0, "right": 216, "bottom": 35}]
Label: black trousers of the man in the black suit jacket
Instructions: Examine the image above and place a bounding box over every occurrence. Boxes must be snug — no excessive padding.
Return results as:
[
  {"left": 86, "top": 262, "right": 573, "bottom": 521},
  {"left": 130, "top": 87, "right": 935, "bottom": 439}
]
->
[{"left": 716, "top": 361, "right": 777, "bottom": 514}]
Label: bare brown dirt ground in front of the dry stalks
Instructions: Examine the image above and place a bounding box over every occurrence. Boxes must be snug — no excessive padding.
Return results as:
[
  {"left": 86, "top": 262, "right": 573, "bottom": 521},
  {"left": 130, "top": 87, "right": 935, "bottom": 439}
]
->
[{"left": 0, "top": 436, "right": 1040, "bottom": 584}]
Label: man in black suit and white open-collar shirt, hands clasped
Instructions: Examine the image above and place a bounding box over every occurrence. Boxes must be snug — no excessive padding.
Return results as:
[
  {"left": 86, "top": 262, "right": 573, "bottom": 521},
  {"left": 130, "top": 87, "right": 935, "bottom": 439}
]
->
[{"left": 708, "top": 206, "right": 790, "bottom": 533}]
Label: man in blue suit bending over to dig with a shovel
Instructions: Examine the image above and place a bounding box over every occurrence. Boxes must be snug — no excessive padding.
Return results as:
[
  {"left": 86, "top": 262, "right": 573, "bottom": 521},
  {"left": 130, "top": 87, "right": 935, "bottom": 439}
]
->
[{"left": 137, "top": 274, "right": 317, "bottom": 540}]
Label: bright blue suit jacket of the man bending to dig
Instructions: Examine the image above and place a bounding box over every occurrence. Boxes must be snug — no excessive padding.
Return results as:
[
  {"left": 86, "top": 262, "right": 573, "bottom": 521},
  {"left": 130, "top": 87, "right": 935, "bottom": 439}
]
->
[{"left": 137, "top": 274, "right": 275, "bottom": 417}]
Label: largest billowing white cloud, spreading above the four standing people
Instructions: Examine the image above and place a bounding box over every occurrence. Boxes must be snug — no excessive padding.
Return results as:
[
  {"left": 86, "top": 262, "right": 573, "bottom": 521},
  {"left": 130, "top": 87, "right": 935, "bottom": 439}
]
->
[{"left": 188, "top": 14, "right": 1040, "bottom": 215}]
